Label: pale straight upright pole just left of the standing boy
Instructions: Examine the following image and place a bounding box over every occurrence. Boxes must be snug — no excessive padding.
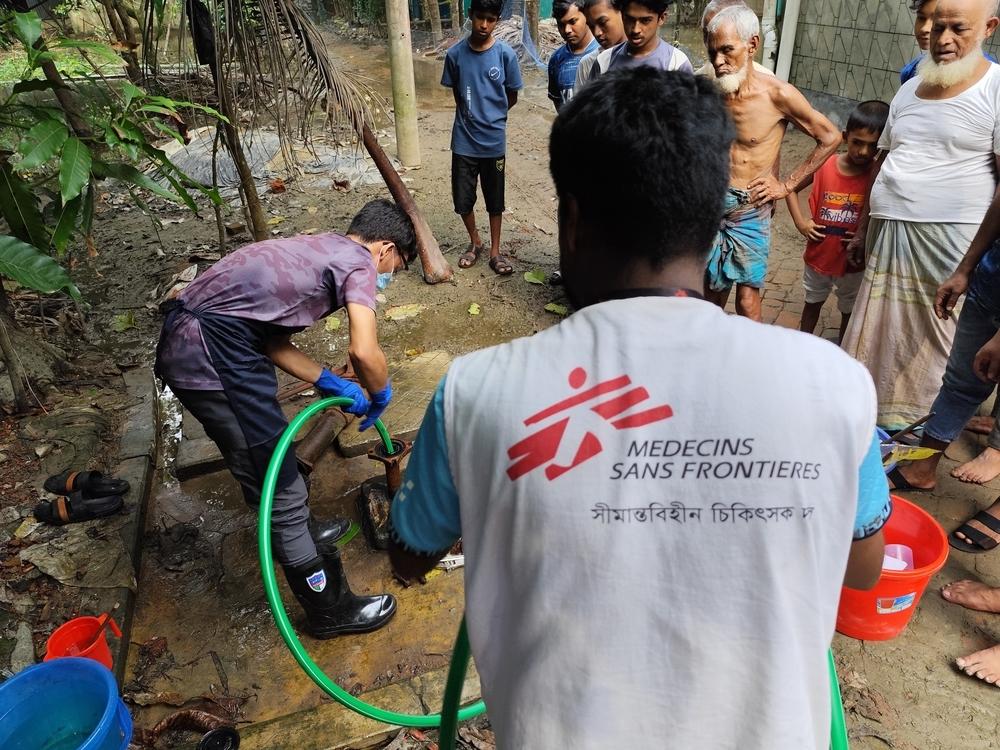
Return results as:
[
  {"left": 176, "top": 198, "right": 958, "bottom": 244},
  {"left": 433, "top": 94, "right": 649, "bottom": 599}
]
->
[{"left": 385, "top": 0, "right": 420, "bottom": 167}]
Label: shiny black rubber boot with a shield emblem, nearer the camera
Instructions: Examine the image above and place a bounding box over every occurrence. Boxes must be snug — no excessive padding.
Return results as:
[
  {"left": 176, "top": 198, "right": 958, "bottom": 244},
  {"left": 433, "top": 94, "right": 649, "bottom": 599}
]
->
[{"left": 284, "top": 547, "right": 396, "bottom": 639}]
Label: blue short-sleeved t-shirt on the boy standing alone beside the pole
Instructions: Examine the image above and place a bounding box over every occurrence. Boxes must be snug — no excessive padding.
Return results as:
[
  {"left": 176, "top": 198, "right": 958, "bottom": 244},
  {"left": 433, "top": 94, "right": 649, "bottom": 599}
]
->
[{"left": 441, "top": 39, "right": 524, "bottom": 159}]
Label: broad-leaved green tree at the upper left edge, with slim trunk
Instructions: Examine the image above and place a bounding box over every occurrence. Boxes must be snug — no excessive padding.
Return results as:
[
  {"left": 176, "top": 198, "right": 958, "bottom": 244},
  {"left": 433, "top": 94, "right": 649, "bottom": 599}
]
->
[{"left": 0, "top": 10, "right": 224, "bottom": 409}]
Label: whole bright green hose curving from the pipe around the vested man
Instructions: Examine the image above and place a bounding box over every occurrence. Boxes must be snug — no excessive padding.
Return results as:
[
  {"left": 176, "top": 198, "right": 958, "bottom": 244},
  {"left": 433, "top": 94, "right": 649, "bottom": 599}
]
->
[{"left": 257, "top": 397, "right": 848, "bottom": 750}]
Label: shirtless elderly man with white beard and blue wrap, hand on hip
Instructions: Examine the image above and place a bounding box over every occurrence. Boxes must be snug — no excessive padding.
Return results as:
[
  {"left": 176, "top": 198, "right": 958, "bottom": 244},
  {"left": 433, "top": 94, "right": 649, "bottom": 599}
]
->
[{"left": 705, "top": 5, "right": 841, "bottom": 320}]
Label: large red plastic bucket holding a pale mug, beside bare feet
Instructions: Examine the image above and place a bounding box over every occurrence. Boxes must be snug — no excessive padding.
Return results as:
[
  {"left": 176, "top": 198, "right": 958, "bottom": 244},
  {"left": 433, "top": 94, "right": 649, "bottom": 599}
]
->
[{"left": 837, "top": 495, "right": 948, "bottom": 641}]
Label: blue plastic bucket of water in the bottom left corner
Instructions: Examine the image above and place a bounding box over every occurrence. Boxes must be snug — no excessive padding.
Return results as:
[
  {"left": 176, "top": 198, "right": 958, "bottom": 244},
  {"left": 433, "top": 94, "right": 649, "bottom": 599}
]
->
[{"left": 0, "top": 656, "right": 132, "bottom": 750}]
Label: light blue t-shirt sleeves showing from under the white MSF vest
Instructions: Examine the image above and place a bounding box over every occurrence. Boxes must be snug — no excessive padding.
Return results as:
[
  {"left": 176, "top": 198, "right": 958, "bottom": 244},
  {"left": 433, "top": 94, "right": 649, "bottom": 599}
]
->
[{"left": 391, "top": 376, "right": 892, "bottom": 554}]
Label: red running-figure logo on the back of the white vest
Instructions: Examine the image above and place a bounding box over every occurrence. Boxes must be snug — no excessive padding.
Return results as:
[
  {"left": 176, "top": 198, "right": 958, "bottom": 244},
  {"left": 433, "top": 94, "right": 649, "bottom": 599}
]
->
[{"left": 507, "top": 367, "right": 674, "bottom": 482}]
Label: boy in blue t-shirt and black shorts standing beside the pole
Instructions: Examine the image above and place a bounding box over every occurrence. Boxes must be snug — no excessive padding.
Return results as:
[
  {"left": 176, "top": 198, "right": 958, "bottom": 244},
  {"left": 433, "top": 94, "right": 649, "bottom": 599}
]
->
[{"left": 441, "top": 0, "right": 524, "bottom": 276}]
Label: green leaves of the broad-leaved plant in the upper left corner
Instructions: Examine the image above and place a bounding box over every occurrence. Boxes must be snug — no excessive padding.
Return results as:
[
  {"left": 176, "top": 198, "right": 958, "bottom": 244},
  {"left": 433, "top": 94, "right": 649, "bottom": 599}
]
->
[{"left": 0, "top": 12, "right": 221, "bottom": 280}]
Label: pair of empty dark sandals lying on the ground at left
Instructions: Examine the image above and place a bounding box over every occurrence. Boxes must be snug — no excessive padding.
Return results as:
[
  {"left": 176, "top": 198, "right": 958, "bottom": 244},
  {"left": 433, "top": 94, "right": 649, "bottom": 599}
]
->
[{"left": 34, "top": 469, "right": 129, "bottom": 526}]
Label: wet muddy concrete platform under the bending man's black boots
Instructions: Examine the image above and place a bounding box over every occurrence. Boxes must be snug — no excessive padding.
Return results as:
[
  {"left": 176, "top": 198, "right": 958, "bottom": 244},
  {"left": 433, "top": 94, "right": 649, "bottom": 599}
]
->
[{"left": 126, "top": 440, "right": 464, "bottom": 736}]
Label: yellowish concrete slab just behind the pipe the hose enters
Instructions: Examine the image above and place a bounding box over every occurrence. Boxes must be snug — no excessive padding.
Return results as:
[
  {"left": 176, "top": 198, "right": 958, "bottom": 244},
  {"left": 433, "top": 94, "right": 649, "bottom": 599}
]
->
[{"left": 337, "top": 350, "right": 451, "bottom": 456}]
